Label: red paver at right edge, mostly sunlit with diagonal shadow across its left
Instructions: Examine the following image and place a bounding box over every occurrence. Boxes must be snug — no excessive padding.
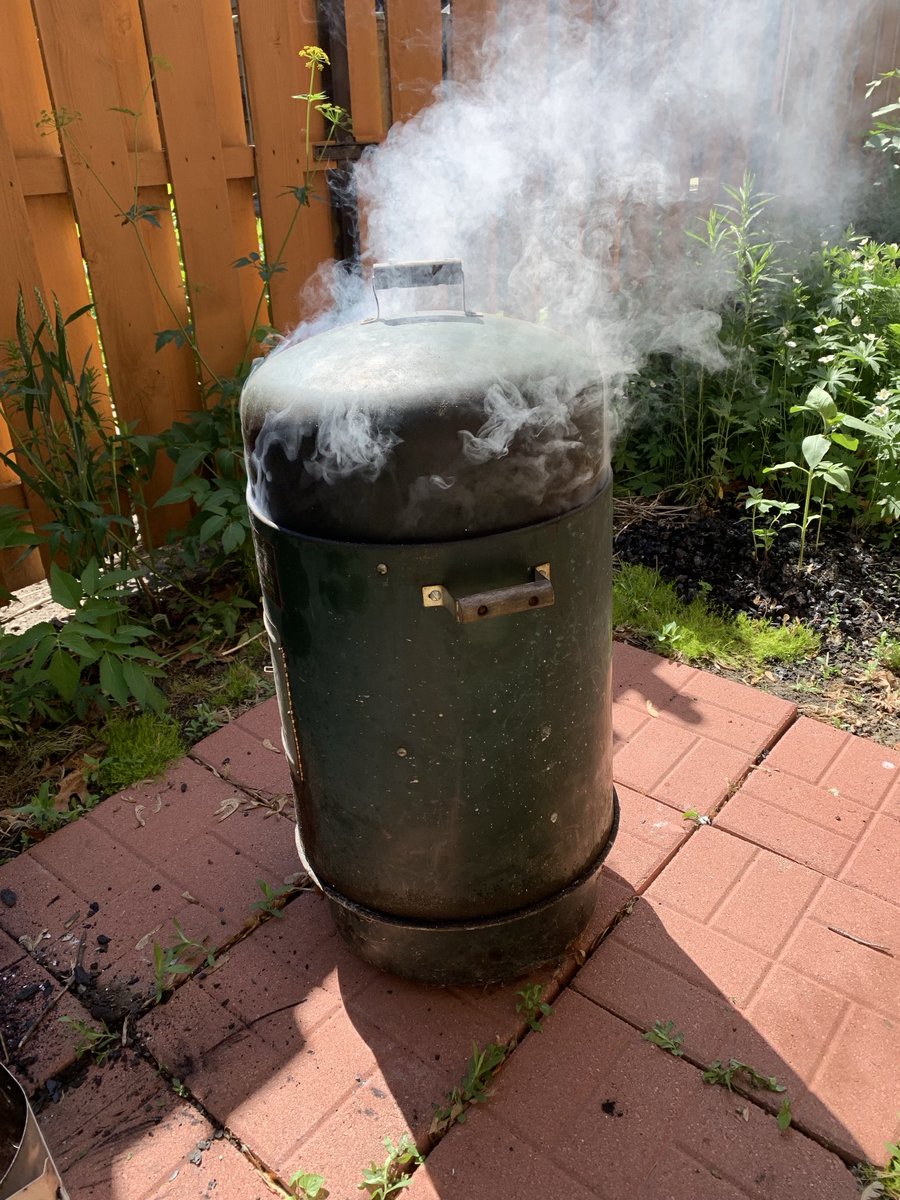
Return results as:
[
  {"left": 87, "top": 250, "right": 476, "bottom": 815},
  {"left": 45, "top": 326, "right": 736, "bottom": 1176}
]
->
[{"left": 572, "top": 828, "right": 900, "bottom": 1160}]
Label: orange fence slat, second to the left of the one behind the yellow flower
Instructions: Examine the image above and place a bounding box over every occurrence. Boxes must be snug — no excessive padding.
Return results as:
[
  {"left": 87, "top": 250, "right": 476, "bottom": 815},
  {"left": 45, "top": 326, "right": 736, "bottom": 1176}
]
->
[{"left": 34, "top": 0, "right": 197, "bottom": 534}]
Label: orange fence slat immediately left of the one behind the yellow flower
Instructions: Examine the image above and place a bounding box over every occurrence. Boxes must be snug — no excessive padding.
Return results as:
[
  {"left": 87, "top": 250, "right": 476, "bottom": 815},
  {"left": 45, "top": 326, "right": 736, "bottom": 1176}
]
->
[{"left": 142, "top": 0, "right": 252, "bottom": 377}]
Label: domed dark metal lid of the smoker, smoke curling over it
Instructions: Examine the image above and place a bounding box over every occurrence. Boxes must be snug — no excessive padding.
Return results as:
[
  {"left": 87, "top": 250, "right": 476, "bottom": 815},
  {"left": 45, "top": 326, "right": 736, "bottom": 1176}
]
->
[{"left": 241, "top": 264, "right": 605, "bottom": 542}]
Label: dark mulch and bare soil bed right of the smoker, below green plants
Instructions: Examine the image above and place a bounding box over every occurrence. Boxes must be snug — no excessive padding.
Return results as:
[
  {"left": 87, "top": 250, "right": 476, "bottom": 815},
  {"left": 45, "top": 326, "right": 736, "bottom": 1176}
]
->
[{"left": 614, "top": 502, "right": 900, "bottom": 746}]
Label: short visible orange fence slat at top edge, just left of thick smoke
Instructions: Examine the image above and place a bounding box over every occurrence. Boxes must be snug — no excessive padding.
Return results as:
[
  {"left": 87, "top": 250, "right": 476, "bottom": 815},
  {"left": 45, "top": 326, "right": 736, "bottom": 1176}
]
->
[{"left": 384, "top": 0, "right": 443, "bottom": 121}]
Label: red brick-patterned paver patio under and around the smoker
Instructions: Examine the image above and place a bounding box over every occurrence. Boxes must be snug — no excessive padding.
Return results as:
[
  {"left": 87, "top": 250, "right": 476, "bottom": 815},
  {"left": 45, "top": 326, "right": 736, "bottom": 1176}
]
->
[{"left": 0, "top": 644, "right": 900, "bottom": 1200}]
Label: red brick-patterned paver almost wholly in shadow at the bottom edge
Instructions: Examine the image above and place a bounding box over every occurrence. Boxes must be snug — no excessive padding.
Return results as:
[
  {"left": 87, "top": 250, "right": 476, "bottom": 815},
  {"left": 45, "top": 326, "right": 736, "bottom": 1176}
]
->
[{"left": 408, "top": 992, "right": 858, "bottom": 1200}]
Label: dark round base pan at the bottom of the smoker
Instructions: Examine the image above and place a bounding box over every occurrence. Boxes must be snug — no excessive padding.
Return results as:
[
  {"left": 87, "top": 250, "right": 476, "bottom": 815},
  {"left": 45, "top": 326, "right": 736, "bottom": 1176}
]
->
[{"left": 295, "top": 788, "right": 619, "bottom": 986}]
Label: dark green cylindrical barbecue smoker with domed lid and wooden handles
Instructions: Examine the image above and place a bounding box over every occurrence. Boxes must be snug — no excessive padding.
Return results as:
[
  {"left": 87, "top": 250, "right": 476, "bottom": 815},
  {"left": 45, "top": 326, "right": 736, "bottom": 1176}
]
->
[{"left": 241, "top": 263, "right": 618, "bottom": 984}]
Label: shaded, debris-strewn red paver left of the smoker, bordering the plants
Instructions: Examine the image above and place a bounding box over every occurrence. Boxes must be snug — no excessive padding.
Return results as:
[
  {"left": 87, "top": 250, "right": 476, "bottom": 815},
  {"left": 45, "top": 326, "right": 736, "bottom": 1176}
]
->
[{"left": 0, "top": 744, "right": 299, "bottom": 1016}]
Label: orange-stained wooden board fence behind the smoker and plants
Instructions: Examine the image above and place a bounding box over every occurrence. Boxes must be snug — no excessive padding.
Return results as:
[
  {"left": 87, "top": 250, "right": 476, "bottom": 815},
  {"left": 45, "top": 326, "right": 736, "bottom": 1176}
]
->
[{"left": 0, "top": 0, "right": 900, "bottom": 600}]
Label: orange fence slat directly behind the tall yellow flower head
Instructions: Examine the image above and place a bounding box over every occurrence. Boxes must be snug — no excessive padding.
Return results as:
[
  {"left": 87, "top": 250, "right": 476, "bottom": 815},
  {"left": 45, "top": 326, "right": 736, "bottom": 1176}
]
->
[{"left": 238, "top": 0, "right": 334, "bottom": 329}]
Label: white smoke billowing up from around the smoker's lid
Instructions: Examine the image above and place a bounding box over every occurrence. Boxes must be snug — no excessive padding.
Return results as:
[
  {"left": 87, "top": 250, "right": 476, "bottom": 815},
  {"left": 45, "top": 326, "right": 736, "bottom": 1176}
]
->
[{"left": 252, "top": 0, "right": 875, "bottom": 493}]
